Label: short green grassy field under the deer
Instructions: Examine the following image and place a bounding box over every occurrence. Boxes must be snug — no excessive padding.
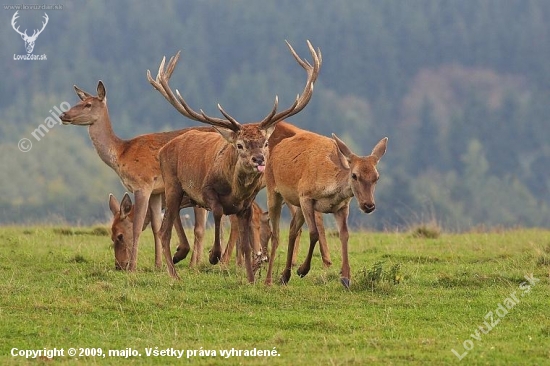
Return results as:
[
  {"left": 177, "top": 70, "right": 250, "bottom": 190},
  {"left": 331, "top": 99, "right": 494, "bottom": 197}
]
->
[{"left": 0, "top": 227, "right": 550, "bottom": 365}]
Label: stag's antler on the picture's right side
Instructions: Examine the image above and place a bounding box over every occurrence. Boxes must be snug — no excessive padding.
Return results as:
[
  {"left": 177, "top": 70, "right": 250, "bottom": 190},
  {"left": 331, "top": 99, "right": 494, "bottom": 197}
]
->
[{"left": 260, "top": 40, "right": 323, "bottom": 129}]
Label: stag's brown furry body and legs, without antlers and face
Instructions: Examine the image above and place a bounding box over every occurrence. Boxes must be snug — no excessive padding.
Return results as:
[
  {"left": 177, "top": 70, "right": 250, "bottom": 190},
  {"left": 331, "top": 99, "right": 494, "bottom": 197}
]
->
[{"left": 159, "top": 124, "right": 268, "bottom": 282}]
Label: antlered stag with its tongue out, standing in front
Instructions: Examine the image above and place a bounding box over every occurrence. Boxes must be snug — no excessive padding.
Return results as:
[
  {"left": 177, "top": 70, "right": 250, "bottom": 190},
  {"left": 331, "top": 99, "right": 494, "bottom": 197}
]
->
[{"left": 147, "top": 41, "right": 322, "bottom": 282}]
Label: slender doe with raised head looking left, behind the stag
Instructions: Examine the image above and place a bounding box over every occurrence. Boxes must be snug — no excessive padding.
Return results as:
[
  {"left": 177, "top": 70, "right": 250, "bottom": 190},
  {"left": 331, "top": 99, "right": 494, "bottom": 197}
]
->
[{"left": 59, "top": 81, "right": 209, "bottom": 270}]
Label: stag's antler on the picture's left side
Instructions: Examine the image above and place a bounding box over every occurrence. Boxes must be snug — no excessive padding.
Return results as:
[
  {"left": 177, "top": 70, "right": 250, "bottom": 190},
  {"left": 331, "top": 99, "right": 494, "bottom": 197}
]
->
[{"left": 147, "top": 51, "right": 241, "bottom": 132}]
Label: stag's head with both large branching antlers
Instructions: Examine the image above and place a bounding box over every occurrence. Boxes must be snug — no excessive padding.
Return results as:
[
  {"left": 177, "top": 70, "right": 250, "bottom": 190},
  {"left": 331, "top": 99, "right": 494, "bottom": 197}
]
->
[{"left": 147, "top": 41, "right": 322, "bottom": 173}]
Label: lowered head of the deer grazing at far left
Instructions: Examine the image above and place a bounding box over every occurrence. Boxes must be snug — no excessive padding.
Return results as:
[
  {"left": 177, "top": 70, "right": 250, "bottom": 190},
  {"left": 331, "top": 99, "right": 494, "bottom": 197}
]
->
[{"left": 109, "top": 193, "right": 151, "bottom": 270}]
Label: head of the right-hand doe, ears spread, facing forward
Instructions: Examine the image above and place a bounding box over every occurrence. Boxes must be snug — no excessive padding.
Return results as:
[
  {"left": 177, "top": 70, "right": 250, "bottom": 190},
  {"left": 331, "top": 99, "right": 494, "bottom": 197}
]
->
[{"left": 332, "top": 134, "right": 388, "bottom": 213}]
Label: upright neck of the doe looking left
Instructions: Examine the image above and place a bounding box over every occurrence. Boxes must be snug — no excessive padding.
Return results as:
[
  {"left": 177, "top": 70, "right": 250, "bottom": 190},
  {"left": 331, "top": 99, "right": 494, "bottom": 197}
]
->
[{"left": 88, "top": 107, "right": 124, "bottom": 172}]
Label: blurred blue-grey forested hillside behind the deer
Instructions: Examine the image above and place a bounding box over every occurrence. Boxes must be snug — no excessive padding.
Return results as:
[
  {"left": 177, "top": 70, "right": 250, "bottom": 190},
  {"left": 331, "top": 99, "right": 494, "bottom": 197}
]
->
[{"left": 0, "top": 0, "right": 550, "bottom": 230}]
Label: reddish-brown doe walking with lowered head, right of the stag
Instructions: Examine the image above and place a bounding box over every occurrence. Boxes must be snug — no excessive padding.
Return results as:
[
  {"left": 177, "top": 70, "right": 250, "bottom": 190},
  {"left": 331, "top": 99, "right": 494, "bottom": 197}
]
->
[{"left": 265, "top": 123, "right": 388, "bottom": 288}]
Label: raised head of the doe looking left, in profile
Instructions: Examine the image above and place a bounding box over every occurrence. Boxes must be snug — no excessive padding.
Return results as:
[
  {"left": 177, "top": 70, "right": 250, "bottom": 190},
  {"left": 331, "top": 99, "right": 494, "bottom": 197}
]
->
[{"left": 59, "top": 80, "right": 107, "bottom": 126}]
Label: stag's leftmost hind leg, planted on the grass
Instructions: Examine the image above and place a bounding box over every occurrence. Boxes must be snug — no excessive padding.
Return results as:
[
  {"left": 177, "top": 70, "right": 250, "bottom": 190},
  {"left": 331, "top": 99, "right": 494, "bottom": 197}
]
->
[{"left": 160, "top": 186, "right": 184, "bottom": 279}]
